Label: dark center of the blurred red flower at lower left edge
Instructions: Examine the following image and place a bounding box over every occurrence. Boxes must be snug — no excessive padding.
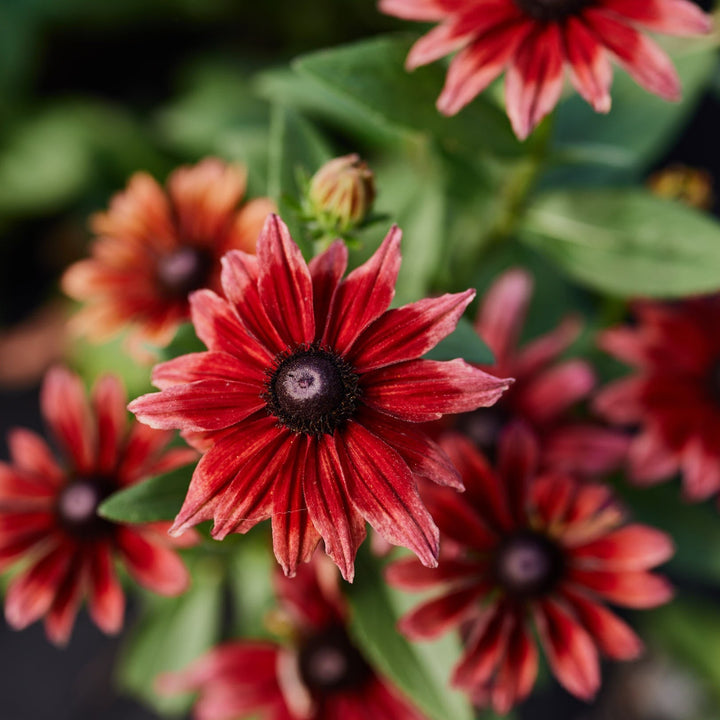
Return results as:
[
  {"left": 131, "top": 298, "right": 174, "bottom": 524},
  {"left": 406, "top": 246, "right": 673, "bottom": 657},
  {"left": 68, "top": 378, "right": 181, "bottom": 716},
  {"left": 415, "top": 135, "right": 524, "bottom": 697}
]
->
[{"left": 55, "top": 478, "right": 113, "bottom": 538}]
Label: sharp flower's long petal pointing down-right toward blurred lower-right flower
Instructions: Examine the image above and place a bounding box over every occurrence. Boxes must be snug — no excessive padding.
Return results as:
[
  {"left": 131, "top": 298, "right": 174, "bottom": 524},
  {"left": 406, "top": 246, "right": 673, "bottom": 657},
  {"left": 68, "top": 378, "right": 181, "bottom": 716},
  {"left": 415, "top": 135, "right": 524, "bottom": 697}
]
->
[{"left": 335, "top": 421, "right": 439, "bottom": 567}]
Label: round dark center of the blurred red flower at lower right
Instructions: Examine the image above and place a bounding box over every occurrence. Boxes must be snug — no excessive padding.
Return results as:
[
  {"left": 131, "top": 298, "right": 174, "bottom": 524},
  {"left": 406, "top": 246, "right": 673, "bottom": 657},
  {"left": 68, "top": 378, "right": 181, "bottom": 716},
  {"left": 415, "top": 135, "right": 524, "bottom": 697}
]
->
[{"left": 495, "top": 530, "right": 565, "bottom": 598}]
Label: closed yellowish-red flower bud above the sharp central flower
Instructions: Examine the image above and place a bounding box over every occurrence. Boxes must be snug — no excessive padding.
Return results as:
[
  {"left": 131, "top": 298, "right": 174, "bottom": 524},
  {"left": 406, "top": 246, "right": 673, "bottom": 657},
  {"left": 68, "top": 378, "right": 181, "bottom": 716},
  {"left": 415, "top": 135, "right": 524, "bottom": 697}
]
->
[{"left": 307, "top": 154, "right": 375, "bottom": 236}]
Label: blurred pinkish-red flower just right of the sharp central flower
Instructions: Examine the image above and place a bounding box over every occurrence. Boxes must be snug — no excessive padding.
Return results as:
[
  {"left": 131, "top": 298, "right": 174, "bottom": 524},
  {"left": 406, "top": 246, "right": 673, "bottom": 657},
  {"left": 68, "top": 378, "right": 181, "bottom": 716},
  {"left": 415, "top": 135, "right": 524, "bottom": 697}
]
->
[{"left": 455, "top": 269, "right": 628, "bottom": 475}]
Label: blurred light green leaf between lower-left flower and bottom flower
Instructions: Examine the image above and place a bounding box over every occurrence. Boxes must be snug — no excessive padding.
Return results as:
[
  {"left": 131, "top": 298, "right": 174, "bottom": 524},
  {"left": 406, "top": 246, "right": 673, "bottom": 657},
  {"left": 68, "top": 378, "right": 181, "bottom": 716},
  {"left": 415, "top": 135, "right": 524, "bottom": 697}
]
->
[{"left": 117, "top": 556, "right": 222, "bottom": 715}]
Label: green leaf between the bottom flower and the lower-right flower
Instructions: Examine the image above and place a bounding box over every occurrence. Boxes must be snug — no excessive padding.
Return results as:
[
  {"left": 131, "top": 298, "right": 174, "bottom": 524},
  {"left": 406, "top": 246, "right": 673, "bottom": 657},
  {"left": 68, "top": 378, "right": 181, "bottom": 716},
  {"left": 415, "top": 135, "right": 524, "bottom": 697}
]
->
[{"left": 349, "top": 552, "right": 474, "bottom": 720}]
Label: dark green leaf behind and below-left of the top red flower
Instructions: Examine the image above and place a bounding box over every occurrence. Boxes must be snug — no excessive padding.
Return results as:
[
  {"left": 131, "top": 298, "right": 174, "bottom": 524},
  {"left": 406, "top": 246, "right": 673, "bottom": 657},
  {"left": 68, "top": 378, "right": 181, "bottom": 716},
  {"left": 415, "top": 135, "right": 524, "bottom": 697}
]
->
[{"left": 293, "top": 35, "right": 524, "bottom": 154}]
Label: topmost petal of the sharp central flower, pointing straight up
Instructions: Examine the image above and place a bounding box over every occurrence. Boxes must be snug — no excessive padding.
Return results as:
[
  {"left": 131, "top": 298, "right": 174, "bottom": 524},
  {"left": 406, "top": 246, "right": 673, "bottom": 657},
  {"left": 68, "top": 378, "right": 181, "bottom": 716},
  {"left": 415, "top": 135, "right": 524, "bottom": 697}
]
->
[{"left": 257, "top": 214, "right": 315, "bottom": 346}]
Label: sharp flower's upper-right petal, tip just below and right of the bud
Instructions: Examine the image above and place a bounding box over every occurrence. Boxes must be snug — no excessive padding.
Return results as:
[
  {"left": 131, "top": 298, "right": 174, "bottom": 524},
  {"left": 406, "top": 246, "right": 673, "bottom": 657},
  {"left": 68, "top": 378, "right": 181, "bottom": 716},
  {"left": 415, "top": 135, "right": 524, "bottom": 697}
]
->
[{"left": 322, "top": 226, "right": 402, "bottom": 354}]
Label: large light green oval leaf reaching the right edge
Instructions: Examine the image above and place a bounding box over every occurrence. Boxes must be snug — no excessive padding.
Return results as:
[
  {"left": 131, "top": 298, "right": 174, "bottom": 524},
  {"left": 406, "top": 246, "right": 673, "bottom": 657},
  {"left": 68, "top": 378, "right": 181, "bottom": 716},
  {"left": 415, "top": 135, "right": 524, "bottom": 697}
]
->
[{"left": 521, "top": 189, "right": 720, "bottom": 297}]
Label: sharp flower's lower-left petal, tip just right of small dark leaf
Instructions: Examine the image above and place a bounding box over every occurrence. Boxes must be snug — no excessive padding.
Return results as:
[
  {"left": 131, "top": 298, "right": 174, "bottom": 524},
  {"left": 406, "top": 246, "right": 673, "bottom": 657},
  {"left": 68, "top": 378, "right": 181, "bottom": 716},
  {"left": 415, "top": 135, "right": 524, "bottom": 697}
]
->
[{"left": 170, "top": 415, "right": 289, "bottom": 535}]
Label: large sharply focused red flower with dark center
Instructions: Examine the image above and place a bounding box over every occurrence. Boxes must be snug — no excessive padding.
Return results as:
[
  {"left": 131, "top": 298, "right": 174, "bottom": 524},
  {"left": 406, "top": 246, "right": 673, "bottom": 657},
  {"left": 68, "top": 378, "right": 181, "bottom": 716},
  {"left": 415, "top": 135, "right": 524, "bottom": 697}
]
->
[{"left": 130, "top": 215, "right": 510, "bottom": 580}]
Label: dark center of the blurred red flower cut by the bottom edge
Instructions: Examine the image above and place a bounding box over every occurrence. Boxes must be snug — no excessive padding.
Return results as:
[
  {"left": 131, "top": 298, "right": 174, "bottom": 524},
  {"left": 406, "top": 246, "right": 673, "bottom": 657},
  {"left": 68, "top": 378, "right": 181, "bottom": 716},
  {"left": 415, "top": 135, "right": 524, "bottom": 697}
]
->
[{"left": 299, "top": 627, "right": 372, "bottom": 697}]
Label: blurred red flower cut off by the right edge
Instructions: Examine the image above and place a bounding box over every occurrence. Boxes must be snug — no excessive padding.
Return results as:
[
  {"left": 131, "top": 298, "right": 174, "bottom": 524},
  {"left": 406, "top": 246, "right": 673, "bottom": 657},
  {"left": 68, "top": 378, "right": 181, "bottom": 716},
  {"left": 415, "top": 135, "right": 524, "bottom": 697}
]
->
[{"left": 596, "top": 296, "right": 720, "bottom": 500}]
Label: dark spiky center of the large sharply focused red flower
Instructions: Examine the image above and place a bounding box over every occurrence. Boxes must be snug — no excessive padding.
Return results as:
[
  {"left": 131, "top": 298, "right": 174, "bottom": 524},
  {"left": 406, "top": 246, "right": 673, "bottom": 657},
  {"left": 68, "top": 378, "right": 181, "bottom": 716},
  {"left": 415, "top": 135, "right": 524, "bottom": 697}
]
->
[{"left": 263, "top": 345, "right": 360, "bottom": 435}]
